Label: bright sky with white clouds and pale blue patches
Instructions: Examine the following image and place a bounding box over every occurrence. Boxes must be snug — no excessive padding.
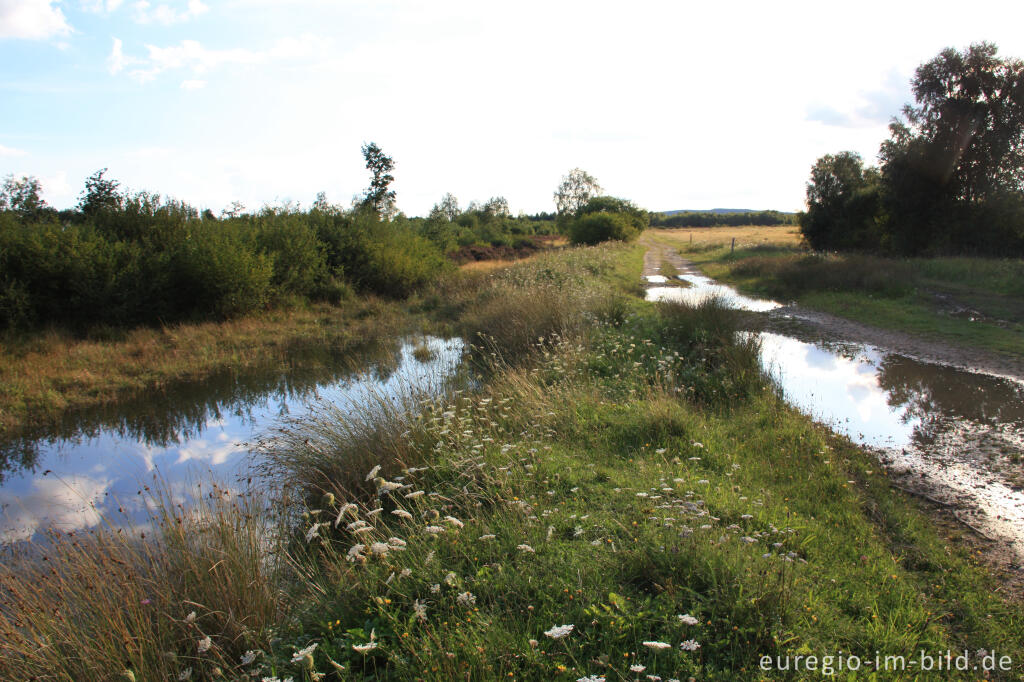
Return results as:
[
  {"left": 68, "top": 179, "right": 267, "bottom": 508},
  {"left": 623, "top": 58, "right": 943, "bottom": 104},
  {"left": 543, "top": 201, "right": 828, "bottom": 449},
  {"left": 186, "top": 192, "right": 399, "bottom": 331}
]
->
[{"left": 0, "top": 0, "right": 1024, "bottom": 215}]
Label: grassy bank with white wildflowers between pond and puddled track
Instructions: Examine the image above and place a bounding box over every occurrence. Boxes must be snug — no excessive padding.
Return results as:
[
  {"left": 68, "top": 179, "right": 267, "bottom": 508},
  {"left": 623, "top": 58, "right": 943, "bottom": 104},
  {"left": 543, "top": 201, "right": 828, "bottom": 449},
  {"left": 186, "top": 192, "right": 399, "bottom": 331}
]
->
[{"left": 0, "top": 241, "right": 1024, "bottom": 681}]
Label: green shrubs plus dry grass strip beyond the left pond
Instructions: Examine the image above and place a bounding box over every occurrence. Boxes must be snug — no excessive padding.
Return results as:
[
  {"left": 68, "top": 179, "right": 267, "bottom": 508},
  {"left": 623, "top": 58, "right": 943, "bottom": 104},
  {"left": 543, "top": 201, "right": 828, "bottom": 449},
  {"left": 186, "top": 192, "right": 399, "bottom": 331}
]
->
[{"left": 0, "top": 153, "right": 647, "bottom": 431}]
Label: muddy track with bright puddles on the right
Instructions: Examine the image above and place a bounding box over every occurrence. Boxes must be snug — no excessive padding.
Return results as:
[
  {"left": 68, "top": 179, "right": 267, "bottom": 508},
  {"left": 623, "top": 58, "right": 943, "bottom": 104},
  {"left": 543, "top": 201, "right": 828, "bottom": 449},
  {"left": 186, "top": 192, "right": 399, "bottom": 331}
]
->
[{"left": 644, "top": 244, "right": 1024, "bottom": 565}]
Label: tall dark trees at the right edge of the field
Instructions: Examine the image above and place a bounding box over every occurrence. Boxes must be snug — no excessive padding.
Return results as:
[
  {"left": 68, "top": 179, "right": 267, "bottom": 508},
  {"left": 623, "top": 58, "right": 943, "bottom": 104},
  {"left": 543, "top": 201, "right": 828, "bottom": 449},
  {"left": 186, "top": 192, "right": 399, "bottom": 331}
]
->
[{"left": 800, "top": 43, "right": 1024, "bottom": 257}]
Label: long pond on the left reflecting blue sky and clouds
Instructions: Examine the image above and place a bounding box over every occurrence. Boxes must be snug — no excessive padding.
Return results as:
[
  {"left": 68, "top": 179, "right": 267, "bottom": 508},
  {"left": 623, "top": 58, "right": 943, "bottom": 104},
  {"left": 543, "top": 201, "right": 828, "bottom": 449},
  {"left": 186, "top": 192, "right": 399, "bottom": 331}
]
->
[{"left": 0, "top": 337, "right": 463, "bottom": 543}]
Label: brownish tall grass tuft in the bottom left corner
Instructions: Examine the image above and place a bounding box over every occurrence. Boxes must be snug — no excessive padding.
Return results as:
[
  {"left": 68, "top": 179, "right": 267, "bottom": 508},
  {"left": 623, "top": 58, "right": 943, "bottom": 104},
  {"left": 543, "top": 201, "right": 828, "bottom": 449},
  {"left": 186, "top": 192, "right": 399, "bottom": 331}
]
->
[{"left": 0, "top": 477, "right": 290, "bottom": 681}]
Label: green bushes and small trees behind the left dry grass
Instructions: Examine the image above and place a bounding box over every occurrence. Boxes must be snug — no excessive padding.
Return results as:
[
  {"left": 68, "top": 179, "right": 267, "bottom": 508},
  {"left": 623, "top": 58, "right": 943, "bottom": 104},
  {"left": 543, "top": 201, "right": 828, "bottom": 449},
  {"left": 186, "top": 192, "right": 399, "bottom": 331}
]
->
[{"left": 0, "top": 148, "right": 647, "bottom": 331}]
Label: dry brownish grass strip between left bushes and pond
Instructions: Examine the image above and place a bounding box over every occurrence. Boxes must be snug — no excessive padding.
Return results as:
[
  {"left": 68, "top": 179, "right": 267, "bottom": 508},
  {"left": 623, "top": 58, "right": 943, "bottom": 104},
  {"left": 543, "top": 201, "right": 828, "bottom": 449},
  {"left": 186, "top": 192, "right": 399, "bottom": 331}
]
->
[{"left": 0, "top": 299, "right": 400, "bottom": 433}]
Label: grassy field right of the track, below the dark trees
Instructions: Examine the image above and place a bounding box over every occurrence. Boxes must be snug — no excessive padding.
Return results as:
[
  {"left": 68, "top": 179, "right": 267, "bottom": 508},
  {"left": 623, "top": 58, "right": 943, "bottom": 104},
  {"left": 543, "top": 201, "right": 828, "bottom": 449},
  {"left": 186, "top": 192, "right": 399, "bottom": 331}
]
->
[{"left": 656, "top": 227, "right": 1024, "bottom": 356}]
